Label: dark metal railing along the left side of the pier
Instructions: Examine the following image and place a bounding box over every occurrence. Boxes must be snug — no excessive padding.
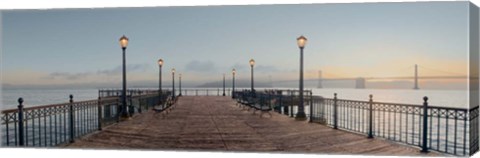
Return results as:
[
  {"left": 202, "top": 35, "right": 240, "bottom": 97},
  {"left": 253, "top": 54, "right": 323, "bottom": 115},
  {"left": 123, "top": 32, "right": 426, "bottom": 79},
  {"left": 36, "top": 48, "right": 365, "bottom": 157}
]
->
[{"left": 0, "top": 90, "right": 171, "bottom": 147}]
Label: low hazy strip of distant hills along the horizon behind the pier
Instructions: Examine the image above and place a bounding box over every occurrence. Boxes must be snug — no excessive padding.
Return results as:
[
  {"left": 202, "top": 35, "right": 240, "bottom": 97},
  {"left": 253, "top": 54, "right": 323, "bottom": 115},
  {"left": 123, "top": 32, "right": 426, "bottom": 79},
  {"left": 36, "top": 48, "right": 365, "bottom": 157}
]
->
[{"left": 1, "top": 79, "right": 468, "bottom": 90}]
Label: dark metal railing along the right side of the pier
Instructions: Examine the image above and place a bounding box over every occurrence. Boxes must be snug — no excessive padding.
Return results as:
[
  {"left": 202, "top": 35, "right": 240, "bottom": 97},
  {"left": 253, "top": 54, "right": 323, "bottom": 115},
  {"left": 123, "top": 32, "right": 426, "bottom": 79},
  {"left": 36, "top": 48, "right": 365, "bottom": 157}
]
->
[{"left": 235, "top": 90, "right": 479, "bottom": 156}]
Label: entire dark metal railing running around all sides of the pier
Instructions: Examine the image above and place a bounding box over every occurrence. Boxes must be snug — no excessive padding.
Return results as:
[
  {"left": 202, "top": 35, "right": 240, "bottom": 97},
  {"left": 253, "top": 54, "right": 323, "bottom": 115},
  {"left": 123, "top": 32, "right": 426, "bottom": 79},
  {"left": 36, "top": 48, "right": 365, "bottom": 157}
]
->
[{"left": 1, "top": 89, "right": 479, "bottom": 156}]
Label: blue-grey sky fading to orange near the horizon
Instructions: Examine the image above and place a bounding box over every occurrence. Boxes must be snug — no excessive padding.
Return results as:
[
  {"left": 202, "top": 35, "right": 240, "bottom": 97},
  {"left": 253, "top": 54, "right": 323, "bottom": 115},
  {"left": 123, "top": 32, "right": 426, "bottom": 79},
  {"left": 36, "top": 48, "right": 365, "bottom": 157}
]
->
[{"left": 1, "top": 2, "right": 468, "bottom": 89}]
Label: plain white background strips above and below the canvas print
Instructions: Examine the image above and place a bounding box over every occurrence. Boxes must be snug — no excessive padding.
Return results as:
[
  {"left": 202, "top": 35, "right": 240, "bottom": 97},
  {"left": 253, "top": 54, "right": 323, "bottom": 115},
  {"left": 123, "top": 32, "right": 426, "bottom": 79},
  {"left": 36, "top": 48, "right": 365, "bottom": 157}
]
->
[{"left": 0, "top": 0, "right": 480, "bottom": 158}]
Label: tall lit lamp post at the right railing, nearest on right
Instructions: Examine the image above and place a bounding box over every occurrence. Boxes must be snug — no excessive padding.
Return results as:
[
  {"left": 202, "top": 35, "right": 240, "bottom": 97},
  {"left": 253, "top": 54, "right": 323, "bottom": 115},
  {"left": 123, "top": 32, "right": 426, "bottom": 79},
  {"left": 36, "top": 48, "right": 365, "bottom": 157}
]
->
[{"left": 296, "top": 36, "right": 312, "bottom": 120}]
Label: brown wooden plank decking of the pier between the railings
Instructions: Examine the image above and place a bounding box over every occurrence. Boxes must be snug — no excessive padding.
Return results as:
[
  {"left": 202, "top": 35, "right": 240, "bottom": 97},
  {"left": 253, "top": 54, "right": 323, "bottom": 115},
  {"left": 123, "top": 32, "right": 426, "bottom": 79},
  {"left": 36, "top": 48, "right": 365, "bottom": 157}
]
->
[{"left": 66, "top": 96, "right": 437, "bottom": 156}]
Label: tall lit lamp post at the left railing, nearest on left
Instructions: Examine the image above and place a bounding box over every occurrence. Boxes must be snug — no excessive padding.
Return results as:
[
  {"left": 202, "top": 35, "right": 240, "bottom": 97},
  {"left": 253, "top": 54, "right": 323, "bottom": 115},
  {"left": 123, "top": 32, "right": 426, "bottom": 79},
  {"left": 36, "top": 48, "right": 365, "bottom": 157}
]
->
[{"left": 119, "top": 35, "right": 129, "bottom": 118}]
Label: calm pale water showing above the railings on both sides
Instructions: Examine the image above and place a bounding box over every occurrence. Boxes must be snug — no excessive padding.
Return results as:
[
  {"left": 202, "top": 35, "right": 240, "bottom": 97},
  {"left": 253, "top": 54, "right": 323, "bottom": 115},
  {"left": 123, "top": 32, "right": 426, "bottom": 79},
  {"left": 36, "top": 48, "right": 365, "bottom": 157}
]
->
[{"left": 1, "top": 88, "right": 468, "bottom": 109}]
